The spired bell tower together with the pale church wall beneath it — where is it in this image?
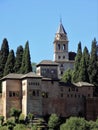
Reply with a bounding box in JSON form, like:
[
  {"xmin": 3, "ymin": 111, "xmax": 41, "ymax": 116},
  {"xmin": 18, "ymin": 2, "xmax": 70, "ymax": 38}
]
[{"xmin": 53, "ymin": 21, "xmax": 74, "ymax": 78}]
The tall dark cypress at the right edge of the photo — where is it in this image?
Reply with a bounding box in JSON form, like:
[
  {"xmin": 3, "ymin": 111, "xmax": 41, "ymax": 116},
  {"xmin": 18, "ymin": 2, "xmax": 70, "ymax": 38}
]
[{"xmin": 88, "ymin": 38, "xmax": 98, "ymax": 86}]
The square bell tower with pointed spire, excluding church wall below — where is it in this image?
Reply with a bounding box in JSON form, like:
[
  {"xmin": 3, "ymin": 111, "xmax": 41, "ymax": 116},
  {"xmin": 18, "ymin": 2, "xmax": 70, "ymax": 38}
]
[{"xmin": 53, "ymin": 21, "xmax": 69, "ymax": 62}]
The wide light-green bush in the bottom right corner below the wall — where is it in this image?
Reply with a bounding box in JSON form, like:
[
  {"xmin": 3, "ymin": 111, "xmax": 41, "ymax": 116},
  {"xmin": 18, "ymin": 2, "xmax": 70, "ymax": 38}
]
[{"xmin": 60, "ymin": 117, "xmax": 98, "ymax": 130}]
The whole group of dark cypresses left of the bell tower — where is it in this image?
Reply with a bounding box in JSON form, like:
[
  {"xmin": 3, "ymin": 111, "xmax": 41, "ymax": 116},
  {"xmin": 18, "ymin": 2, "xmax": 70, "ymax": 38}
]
[{"xmin": 0, "ymin": 38, "xmax": 32, "ymax": 92}]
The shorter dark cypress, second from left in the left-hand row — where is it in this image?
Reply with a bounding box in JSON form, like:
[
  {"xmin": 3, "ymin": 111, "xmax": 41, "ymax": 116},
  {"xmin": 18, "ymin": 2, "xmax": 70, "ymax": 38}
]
[{"xmin": 4, "ymin": 50, "xmax": 15, "ymax": 76}]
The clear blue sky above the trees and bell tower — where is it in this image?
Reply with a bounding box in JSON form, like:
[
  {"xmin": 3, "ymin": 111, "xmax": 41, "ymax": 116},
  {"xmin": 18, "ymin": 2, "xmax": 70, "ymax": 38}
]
[{"xmin": 0, "ymin": 0, "xmax": 98, "ymax": 63}]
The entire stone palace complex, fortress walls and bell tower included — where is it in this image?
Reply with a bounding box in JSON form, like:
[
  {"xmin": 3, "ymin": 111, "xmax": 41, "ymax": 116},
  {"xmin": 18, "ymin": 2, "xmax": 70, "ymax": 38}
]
[{"xmin": 0, "ymin": 23, "xmax": 98, "ymax": 120}]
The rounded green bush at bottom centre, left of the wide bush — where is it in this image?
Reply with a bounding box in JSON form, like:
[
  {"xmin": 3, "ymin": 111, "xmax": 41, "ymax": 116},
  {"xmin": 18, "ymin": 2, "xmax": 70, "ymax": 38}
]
[{"xmin": 48, "ymin": 114, "xmax": 59, "ymax": 130}]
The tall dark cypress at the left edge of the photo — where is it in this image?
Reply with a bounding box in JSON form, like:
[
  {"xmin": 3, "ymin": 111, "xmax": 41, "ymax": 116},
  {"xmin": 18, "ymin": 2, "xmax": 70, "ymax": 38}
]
[{"xmin": 0, "ymin": 38, "xmax": 9, "ymax": 78}]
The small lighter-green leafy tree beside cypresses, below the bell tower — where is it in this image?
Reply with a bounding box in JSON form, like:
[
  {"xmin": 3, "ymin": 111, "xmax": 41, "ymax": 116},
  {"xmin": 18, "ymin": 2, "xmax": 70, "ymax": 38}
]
[{"xmin": 61, "ymin": 69, "xmax": 72, "ymax": 83}]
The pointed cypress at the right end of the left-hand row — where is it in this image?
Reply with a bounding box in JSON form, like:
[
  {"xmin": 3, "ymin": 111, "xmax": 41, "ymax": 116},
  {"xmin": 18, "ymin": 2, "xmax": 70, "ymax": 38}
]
[{"xmin": 21, "ymin": 41, "xmax": 32, "ymax": 74}]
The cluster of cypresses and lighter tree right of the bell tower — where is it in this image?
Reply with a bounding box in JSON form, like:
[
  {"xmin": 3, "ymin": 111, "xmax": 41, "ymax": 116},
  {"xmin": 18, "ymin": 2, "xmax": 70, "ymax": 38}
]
[{"xmin": 62, "ymin": 38, "xmax": 98, "ymax": 86}]
